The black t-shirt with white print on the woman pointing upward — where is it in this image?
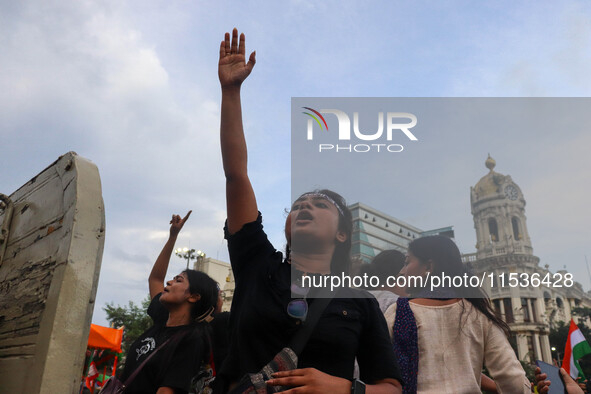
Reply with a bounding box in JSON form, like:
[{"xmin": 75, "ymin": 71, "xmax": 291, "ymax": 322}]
[{"xmin": 121, "ymin": 293, "xmax": 207, "ymax": 394}]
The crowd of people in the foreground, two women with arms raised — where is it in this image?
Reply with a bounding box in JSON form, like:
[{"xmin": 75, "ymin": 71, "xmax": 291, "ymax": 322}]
[{"xmin": 106, "ymin": 29, "xmax": 583, "ymax": 394}]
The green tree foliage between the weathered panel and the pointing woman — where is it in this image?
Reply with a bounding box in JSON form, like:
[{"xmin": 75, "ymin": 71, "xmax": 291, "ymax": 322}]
[{"xmin": 103, "ymin": 296, "xmax": 152, "ymax": 370}]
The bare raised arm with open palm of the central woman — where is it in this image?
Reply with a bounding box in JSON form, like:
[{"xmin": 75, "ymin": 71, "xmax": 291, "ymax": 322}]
[{"xmin": 218, "ymin": 29, "xmax": 258, "ymax": 234}]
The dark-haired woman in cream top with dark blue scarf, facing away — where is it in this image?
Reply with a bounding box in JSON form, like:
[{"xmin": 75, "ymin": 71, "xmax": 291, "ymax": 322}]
[{"xmin": 385, "ymin": 236, "xmax": 531, "ymax": 393}]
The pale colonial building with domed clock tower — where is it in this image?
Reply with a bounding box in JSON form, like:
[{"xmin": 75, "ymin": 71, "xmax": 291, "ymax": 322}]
[{"xmin": 463, "ymin": 156, "xmax": 591, "ymax": 362}]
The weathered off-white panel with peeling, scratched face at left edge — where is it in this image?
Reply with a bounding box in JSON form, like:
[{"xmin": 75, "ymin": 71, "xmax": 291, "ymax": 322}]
[{"xmin": 0, "ymin": 152, "xmax": 105, "ymax": 394}]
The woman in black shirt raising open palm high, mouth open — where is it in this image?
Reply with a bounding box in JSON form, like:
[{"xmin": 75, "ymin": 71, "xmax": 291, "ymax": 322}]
[{"xmin": 218, "ymin": 29, "xmax": 401, "ymax": 394}]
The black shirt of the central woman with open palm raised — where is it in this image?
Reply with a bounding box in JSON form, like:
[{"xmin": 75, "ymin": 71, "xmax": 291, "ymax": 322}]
[{"xmin": 221, "ymin": 214, "xmax": 401, "ymax": 383}]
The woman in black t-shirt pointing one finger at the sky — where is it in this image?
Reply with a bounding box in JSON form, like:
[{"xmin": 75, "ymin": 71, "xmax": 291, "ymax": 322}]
[{"xmin": 121, "ymin": 211, "xmax": 219, "ymax": 394}]
